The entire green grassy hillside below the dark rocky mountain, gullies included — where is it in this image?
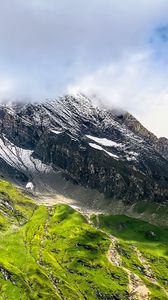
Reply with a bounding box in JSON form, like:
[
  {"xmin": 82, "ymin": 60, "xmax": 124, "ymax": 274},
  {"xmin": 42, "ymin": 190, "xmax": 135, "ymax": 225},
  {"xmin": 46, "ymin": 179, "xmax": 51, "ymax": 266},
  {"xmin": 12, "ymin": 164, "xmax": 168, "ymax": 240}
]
[{"xmin": 0, "ymin": 180, "xmax": 168, "ymax": 300}]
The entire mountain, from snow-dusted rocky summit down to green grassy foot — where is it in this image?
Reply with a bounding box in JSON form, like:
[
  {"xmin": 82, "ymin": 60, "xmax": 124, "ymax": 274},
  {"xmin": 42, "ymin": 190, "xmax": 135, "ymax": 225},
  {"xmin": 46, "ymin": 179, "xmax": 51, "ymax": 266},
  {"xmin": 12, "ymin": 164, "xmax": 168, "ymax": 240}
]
[{"xmin": 0, "ymin": 95, "xmax": 168, "ymax": 300}]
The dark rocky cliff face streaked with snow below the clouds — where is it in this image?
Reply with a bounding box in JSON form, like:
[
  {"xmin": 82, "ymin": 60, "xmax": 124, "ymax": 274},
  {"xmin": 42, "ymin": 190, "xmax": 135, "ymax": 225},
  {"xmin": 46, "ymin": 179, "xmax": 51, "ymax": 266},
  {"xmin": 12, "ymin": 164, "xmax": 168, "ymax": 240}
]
[{"xmin": 0, "ymin": 95, "xmax": 168, "ymax": 202}]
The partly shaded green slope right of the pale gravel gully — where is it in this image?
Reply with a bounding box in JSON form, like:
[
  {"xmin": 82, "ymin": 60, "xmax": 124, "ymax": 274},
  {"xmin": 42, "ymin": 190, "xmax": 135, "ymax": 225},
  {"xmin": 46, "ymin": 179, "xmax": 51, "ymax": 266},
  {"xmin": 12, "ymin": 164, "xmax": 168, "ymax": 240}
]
[{"xmin": 92, "ymin": 215, "xmax": 168, "ymax": 299}]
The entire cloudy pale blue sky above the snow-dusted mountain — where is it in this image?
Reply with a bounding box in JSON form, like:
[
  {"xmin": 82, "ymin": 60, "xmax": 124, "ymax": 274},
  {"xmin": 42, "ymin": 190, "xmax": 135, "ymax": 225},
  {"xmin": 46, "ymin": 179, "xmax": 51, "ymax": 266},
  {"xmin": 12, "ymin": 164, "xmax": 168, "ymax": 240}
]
[{"xmin": 0, "ymin": 0, "xmax": 168, "ymax": 137}]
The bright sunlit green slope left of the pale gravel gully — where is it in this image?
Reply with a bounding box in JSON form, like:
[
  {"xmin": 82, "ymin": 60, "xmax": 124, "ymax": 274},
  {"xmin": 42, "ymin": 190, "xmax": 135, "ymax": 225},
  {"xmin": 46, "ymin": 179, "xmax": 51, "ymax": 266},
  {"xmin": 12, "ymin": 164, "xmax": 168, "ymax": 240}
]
[{"xmin": 0, "ymin": 181, "xmax": 128, "ymax": 300}]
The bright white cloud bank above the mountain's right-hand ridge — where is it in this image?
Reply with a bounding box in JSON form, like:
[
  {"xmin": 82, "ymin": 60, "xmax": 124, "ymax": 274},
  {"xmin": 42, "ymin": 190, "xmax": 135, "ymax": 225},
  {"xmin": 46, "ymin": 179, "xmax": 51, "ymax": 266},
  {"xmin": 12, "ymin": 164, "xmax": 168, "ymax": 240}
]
[{"xmin": 68, "ymin": 49, "xmax": 168, "ymax": 137}]
